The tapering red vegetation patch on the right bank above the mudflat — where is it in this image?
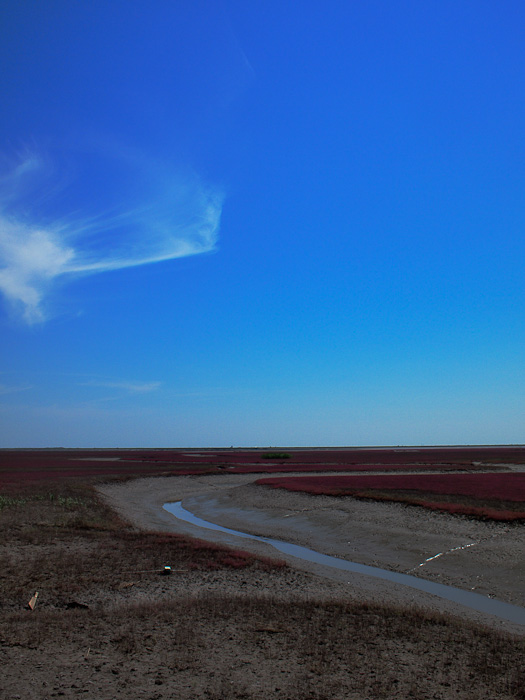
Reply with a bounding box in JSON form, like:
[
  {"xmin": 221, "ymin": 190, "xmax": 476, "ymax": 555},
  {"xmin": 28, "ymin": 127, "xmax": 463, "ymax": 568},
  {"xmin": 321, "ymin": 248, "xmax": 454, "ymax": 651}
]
[{"xmin": 256, "ymin": 472, "xmax": 525, "ymax": 521}]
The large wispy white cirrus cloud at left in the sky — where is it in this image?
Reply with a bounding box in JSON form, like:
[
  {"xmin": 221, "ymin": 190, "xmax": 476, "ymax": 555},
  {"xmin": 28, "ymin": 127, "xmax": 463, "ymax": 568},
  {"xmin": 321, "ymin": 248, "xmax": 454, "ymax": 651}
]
[{"xmin": 0, "ymin": 154, "xmax": 223, "ymax": 324}]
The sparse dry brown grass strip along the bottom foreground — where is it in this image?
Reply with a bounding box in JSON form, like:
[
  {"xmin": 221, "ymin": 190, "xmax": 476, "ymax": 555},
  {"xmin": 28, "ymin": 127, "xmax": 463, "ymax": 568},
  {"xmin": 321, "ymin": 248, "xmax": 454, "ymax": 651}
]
[{"xmin": 2, "ymin": 594, "xmax": 525, "ymax": 700}]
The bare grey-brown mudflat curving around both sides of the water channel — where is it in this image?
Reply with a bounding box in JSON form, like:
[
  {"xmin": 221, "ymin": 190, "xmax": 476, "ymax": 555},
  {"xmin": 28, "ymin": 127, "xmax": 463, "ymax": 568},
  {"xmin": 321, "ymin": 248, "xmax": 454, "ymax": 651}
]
[{"xmin": 99, "ymin": 474, "xmax": 525, "ymax": 634}]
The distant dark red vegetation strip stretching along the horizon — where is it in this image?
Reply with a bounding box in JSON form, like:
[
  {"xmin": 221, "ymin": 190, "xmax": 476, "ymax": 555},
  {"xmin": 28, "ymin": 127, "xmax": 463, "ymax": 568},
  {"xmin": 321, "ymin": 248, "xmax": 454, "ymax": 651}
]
[{"xmin": 0, "ymin": 446, "xmax": 525, "ymax": 490}]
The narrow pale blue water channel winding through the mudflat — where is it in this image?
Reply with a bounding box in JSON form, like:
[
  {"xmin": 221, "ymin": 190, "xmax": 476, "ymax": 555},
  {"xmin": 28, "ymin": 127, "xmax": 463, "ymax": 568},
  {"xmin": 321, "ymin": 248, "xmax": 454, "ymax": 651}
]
[{"xmin": 164, "ymin": 501, "xmax": 525, "ymax": 625}]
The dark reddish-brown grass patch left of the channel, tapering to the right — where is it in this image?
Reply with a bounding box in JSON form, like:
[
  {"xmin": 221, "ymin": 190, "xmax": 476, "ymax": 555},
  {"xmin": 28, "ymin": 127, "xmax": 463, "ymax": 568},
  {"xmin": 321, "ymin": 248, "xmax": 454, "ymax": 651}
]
[{"xmin": 0, "ymin": 481, "xmax": 285, "ymax": 610}]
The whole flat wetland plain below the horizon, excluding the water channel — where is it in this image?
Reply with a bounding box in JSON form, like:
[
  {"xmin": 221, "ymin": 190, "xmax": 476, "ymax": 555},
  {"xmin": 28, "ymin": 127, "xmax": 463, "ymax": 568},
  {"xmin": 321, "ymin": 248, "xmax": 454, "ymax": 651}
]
[{"xmin": 0, "ymin": 446, "xmax": 525, "ymax": 700}]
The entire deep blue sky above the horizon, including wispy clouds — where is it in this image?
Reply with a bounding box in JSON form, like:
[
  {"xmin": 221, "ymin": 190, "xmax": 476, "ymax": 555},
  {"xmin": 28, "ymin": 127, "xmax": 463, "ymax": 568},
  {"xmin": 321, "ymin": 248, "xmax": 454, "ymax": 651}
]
[{"xmin": 0, "ymin": 0, "xmax": 525, "ymax": 447}]
